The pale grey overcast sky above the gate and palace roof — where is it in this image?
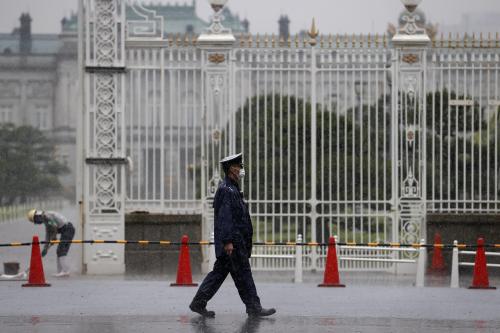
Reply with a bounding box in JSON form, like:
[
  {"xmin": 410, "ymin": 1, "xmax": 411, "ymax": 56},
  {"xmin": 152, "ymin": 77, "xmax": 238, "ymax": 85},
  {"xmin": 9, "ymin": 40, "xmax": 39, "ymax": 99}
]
[{"xmin": 0, "ymin": 0, "xmax": 500, "ymax": 34}]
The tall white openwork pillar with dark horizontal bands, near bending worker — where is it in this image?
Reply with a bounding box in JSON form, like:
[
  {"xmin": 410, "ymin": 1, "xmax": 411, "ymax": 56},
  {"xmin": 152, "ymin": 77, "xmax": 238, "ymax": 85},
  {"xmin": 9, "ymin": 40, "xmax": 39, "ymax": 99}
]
[{"xmin": 79, "ymin": 0, "xmax": 126, "ymax": 274}]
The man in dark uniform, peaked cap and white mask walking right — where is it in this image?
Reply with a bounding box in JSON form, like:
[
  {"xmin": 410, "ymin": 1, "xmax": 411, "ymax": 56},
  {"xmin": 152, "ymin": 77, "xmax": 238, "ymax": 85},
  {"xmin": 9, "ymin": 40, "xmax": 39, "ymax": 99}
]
[{"xmin": 189, "ymin": 153, "xmax": 276, "ymax": 317}]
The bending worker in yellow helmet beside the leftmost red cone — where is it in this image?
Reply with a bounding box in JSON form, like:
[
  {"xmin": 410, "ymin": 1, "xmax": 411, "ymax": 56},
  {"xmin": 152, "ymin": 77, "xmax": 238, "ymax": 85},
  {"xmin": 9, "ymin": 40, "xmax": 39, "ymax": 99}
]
[{"xmin": 28, "ymin": 209, "xmax": 75, "ymax": 277}]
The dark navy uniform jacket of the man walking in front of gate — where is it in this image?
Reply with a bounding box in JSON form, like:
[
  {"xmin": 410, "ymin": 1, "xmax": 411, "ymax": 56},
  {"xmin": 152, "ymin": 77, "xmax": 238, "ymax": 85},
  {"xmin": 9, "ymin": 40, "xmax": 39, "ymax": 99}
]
[{"xmin": 213, "ymin": 177, "xmax": 253, "ymax": 258}]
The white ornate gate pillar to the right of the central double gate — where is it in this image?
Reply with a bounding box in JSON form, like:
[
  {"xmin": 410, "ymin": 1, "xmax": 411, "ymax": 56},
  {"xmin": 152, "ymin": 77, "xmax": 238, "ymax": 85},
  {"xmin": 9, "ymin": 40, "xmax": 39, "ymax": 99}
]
[{"xmin": 392, "ymin": 0, "xmax": 430, "ymax": 249}]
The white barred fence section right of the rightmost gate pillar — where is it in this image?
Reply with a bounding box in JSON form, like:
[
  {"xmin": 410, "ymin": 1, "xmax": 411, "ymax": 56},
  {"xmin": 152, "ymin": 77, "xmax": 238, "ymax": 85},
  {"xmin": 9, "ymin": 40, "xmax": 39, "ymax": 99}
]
[{"xmin": 426, "ymin": 44, "xmax": 500, "ymax": 213}]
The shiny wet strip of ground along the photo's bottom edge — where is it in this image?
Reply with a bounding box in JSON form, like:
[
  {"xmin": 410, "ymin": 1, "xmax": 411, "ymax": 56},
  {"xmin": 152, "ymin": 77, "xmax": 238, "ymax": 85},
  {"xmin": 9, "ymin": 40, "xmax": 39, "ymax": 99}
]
[{"xmin": 0, "ymin": 315, "xmax": 500, "ymax": 333}]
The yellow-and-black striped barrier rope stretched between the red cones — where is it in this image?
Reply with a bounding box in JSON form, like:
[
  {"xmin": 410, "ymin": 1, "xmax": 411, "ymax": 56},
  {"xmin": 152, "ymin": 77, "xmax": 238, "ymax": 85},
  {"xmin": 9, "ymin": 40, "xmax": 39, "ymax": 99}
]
[{"xmin": 0, "ymin": 239, "xmax": 500, "ymax": 249}]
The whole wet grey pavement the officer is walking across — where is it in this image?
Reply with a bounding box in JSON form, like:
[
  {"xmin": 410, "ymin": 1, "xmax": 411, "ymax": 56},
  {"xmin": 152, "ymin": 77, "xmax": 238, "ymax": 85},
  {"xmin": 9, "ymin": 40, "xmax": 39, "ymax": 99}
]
[{"xmin": 0, "ymin": 277, "xmax": 500, "ymax": 333}]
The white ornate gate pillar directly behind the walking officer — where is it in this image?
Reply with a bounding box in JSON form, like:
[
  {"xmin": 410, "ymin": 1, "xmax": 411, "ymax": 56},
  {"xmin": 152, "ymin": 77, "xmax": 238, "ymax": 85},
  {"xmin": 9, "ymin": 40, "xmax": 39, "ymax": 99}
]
[{"xmin": 197, "ymin": 5, "xmax": 236, "ymax": 271}]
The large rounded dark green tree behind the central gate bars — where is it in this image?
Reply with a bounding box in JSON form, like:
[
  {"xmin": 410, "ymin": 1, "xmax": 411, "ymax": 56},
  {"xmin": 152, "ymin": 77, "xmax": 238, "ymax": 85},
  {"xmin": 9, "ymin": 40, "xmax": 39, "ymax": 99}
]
[{"xmin": 236, "ymin": 95, "xmax": 391, "ymax": 204}]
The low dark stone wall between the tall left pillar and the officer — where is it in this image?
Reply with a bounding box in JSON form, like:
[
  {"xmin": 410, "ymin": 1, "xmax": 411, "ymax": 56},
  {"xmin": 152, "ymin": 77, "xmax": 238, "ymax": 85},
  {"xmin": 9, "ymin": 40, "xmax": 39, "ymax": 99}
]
[{"xmin": 125, "ymin": 213, "xmax": 202, "ymax": 277}]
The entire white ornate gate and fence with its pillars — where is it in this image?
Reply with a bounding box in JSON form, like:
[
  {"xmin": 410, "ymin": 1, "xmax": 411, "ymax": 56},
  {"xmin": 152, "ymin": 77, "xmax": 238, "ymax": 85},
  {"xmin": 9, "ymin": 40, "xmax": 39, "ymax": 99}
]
[{"xmin": 82, "ymin": 0, "xmax": 500, "ymax": 272}]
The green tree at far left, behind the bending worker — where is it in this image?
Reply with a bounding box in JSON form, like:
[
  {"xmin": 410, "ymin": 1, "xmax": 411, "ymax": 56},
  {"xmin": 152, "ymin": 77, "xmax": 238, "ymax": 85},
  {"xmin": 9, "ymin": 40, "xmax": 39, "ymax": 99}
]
[{"xmin": 0, "ymin": 124, "xmax": 68, "ymax": 205}]
